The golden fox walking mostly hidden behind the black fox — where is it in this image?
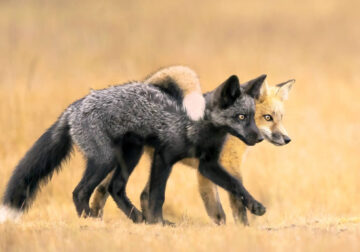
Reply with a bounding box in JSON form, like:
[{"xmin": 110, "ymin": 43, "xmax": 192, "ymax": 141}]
[{"xmin": 91, "ymin": 66, "xmax": 295, "ymax": 225}]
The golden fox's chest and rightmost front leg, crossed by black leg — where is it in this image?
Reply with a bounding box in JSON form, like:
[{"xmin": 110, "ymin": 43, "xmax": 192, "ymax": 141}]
[{"xmin": 220, "ymin": 136, "xmax": 249, "ymax": 226}]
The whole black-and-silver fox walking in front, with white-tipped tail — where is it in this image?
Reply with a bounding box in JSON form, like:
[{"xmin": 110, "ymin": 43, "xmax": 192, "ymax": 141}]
[{"xmin": 0, "ymin": 69, "xmax": 266, "ymax": 224}]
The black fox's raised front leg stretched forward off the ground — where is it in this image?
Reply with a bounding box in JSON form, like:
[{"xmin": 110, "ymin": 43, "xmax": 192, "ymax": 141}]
[{"xmin": 199, "ymin": 154, "xmax": 266, "ymax": 215}]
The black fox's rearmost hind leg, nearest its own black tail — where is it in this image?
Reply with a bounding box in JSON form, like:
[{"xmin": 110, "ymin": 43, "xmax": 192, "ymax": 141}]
[{"xmin": 73, "ymin": 158, "xmax": 115, "ymax": 217}]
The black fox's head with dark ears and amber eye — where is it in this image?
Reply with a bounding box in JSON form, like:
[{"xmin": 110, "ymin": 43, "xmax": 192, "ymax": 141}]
[{"xmin": 205, "ymin": 75, "xmax": 266, "ymax": 145}]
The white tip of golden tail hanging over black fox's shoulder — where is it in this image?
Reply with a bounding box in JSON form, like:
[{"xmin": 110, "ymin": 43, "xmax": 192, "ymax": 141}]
[{"xmin": 183, "ymin": 92, "xmax": 205, "ymax": 121}]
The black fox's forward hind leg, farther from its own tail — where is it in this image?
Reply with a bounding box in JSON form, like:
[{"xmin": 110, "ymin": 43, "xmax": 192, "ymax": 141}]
[{"xmin": 108, "ymin": 135, "xmax": 144, "ymax": 223}]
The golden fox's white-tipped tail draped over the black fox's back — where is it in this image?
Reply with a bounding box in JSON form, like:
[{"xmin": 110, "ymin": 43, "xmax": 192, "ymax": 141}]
[{"xmin": 144, "ymin": 66, "xmax": 205, "ymax": 121}]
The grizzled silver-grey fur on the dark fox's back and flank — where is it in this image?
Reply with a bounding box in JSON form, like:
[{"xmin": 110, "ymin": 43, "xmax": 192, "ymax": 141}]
[{"xmin": 67, "ymin": 83, "xmax": 188, "ymax": 158}]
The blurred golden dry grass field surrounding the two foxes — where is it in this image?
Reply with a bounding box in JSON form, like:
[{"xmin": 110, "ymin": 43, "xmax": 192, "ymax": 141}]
[{"xmin": 0, "ymin": 0, "xmax": 360, "ymax": 251}]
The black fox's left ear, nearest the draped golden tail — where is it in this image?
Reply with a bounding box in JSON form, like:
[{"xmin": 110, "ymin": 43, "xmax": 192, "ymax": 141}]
[{"xmin": 215, "ymin": 75, "xmax": 241, "ymax": 108}]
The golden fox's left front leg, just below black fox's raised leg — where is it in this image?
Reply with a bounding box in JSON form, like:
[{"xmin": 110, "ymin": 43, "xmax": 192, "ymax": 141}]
[{"xmin": 197, "ymin": 172, "xmax": 226, "ymax": 225}]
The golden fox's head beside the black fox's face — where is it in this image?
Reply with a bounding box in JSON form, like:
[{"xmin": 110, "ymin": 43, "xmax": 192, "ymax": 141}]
[{"xmin": 255, "ymin": 80, "xmax": 295, "ymax": 146}]
